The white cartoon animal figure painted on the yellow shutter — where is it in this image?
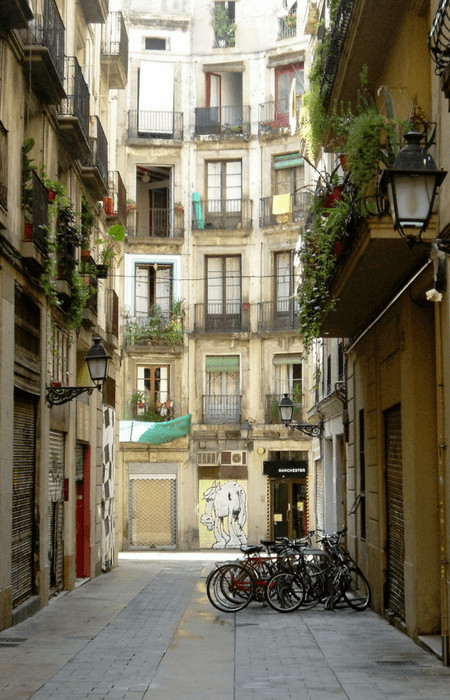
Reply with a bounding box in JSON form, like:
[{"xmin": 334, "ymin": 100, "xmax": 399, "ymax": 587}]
[{"xmin": 200, "ymin": 481, "xmax": 247, "ymax": 549}]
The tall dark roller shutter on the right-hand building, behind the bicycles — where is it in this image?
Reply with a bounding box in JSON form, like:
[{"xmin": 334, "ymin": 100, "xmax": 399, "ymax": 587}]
[{"xmin": 384, "ymin": 406, "xmax": 405, "ymax": 620}]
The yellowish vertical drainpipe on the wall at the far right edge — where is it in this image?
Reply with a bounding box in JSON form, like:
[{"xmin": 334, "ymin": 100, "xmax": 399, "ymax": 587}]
[{"xmin": 434, "ymin": 302, "xmax": 450, "ymax": 666}]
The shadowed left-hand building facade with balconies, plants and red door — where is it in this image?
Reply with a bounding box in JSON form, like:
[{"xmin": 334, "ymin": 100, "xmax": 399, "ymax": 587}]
[{"xmin": 0, "ymin": 0, "xmax": 128, "ymax": 628}]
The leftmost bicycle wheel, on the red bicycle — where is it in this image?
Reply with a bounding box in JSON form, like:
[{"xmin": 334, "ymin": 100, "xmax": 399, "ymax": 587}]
[{"xmin": 206, "ymin": 563, "xmax": 255, "ymax": 612}]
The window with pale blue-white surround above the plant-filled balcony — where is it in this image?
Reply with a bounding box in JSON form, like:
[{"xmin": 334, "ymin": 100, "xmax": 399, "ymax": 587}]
[{"xmin": 135, "ymin": 263, "xmax": 173, "ymax": 323}]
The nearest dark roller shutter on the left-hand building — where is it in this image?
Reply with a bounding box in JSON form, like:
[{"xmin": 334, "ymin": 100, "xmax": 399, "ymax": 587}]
[{"xmin": 11, "ymin": 392, "xmax": 36, "ymax": 606}]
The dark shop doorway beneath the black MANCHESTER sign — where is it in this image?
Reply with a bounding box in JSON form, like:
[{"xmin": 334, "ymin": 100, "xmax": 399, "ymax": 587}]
[{"xmin": 270, "ymin": 479, "xmax": 308, "ymax": 539}]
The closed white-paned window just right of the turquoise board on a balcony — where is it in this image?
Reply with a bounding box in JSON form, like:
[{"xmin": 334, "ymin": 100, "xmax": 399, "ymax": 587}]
[{"xmin": 206, "ymin": 160, "xmax": 242, "ymax": 217}]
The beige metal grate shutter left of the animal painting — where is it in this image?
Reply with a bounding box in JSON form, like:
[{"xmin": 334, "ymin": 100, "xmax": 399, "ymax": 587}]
[{"xmin": 129, "ymin": 475, "xmax": 176, "ymax": 549}]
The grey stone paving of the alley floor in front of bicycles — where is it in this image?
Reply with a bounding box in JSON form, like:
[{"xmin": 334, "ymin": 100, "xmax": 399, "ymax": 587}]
[{"xmin": 0, "ymin": 554, "xmax": 450, "ymax": 700}]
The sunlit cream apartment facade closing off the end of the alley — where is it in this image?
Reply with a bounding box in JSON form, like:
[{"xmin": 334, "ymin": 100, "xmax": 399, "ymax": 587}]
[{"xmin": 119, "ymin": 1, "xmax": 320, "ymax": 549}]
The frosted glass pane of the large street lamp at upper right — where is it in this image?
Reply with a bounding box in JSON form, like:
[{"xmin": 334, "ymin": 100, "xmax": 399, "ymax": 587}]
[{"xmin": 388, "ymin": 173, "xmax": 435, "ymax": 228}]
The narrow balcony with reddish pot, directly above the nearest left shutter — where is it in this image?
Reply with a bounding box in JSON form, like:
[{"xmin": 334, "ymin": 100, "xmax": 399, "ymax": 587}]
[{"xmin": 20, "ymin": 171, "xmax": 48, "ymax": 271}]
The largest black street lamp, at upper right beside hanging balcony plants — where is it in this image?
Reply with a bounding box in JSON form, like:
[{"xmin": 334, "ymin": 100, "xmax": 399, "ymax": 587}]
[{"xmin": 380, "ymin": 131, "xmax": 447, "ymax": 245}]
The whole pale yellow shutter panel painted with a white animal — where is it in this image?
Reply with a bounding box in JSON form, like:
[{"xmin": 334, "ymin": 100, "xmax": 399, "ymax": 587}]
[{"xmin": 199, "ymin": 479, "xmax": 247, "ymax": 549}]
